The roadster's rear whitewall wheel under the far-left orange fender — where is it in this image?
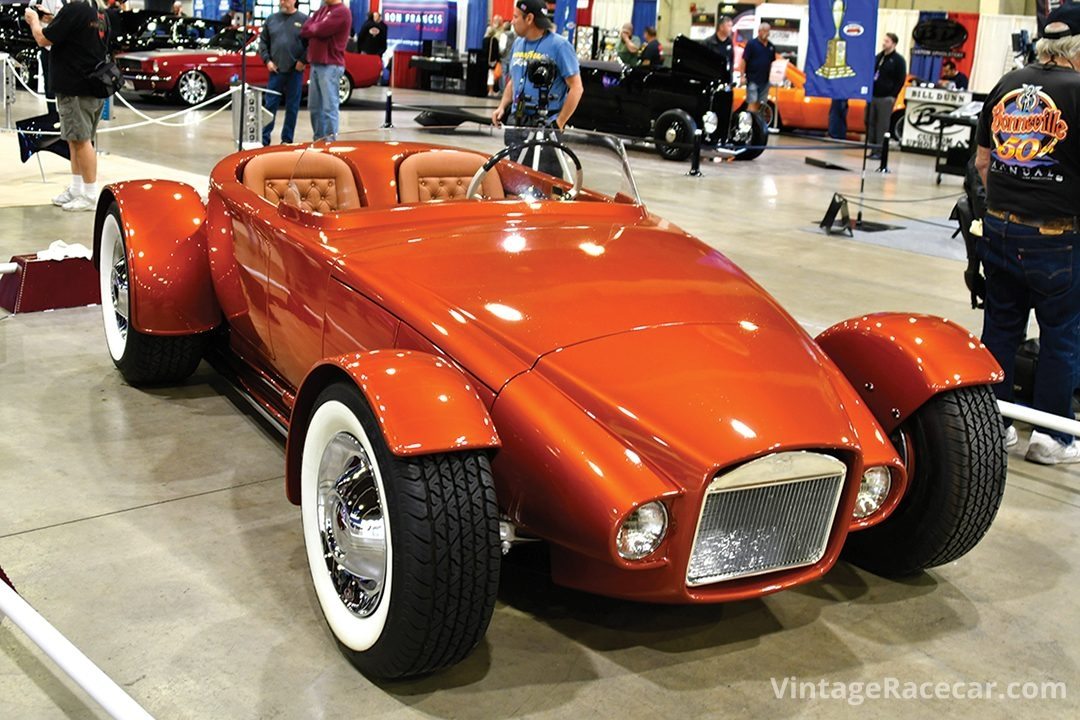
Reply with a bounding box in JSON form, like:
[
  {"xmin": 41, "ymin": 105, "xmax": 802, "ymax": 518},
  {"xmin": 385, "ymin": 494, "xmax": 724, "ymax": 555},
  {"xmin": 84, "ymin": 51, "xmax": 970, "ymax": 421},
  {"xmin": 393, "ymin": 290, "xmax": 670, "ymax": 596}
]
[{"xmin": 98, "ymin": 203, "xmax": 206, "ymax": 385}]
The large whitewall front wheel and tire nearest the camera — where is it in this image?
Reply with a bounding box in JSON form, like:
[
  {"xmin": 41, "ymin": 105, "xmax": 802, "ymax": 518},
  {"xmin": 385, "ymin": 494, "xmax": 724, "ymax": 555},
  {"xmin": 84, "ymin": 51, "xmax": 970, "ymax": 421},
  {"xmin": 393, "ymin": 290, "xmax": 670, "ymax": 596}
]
[{"xmin": 300, "ymin": 383, "xmax": 501, "ymax": 678}]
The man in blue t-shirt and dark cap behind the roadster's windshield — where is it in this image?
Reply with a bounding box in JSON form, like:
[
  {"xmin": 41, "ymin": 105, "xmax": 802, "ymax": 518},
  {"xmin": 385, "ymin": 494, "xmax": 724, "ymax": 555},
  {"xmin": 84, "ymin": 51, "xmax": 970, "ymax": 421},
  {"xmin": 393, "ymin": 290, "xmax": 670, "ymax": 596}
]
[{"xmin": 491, "ymin": 0, "xmax": 584, "ymax": 130}]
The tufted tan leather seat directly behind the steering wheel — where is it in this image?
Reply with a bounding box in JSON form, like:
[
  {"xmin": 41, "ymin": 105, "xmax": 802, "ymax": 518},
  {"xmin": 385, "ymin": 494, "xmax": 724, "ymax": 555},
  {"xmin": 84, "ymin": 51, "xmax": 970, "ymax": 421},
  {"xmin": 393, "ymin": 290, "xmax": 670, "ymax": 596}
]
[{"xmin": 397, "ymin": 150, "xmax": 505, "ymax": 203}]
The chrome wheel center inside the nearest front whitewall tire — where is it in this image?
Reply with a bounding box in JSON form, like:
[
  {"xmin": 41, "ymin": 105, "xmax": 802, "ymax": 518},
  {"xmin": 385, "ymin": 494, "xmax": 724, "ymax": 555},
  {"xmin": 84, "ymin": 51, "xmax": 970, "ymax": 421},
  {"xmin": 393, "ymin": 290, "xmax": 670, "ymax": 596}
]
[{"xmin": 316, "ymin": 432, "xmax": 387, "ymax": 617}]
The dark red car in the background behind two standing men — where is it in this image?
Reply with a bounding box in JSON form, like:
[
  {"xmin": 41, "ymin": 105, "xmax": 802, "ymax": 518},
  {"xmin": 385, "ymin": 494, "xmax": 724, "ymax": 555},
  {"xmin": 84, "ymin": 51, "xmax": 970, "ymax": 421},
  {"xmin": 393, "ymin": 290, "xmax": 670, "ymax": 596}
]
[{"xmin": 117, "ymin": 27, "xmax": 382, "ymax": 106}]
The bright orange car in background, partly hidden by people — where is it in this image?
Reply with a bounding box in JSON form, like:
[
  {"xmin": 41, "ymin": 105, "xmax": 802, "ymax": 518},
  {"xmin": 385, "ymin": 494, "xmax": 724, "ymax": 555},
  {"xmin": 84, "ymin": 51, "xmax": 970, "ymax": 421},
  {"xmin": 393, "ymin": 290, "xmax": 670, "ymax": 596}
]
[{"xmin": 732, "ymin": 64, "xmax": 916, "ymax": 138}]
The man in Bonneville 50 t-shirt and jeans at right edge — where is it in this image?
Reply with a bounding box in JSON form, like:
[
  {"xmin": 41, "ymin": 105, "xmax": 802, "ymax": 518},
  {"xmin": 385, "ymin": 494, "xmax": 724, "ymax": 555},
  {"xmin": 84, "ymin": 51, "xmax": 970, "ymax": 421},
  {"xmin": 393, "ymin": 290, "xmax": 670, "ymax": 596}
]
[{"xmin": 975, "ymin": 5, "xmax": 1080, "ymax": 464}]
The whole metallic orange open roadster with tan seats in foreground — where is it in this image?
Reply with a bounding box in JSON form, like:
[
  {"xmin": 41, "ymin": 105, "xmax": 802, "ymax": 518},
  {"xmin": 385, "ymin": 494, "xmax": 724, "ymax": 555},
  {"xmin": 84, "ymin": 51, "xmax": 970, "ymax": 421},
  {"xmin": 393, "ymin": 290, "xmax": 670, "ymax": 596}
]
[{"xmin": 94, "ymin": 132, "xmax": 1005, "ymax": 678}]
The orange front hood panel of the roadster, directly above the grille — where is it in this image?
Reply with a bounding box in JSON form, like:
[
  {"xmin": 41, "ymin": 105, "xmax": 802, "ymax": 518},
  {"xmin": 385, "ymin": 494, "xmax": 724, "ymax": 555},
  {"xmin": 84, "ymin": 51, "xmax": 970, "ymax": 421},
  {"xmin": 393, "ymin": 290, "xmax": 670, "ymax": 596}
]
[{"xmin": 527, "ymin": 322, "xmax": 859, "ymax": 487}]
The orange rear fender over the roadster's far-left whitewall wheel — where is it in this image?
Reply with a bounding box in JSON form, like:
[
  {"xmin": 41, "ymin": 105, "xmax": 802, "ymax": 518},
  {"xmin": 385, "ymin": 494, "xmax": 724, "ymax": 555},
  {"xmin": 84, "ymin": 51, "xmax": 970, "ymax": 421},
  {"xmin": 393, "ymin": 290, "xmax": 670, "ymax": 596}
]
[{"xmin": 94, "ymin": 180, "xmax": 221, "ymax": 335}]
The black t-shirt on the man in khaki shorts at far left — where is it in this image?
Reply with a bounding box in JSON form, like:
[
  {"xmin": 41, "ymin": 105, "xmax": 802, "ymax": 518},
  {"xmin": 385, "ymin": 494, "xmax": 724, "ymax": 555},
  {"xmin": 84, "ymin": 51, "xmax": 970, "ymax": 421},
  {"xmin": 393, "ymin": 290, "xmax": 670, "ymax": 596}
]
[{"xmin": 43, "ymin": 2, "xmax": 107, "ymax": 95}]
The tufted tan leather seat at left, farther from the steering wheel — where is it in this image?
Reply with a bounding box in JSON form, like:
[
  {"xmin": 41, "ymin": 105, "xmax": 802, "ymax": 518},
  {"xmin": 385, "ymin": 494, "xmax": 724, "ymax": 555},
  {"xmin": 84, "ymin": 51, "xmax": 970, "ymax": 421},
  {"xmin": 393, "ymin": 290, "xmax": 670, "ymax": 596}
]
[{"xmin": 244, "ymin": 150, "xmax": 363, "ymax": 213}]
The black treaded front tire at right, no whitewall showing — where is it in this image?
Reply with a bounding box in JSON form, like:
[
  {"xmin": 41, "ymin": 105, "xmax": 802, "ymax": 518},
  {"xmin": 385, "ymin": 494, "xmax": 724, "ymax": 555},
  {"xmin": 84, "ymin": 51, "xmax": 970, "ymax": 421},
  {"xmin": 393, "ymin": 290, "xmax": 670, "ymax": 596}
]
[{"xmin": 843, "ymin": 385, "xmax": 1008, "ymax": 576}]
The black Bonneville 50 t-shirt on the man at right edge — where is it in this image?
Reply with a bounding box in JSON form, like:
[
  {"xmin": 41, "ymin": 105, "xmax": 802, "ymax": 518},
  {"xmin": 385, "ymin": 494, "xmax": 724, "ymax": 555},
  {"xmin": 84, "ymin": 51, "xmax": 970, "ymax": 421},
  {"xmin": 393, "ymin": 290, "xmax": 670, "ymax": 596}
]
[{"xmin": 976, "ymin": 64, "xmax": 1080, "ymax": 219}]
